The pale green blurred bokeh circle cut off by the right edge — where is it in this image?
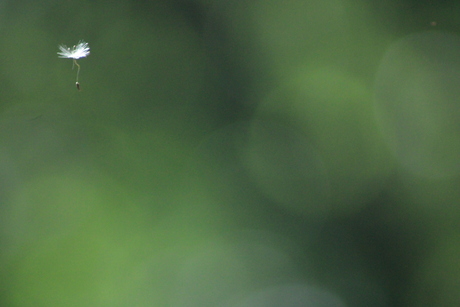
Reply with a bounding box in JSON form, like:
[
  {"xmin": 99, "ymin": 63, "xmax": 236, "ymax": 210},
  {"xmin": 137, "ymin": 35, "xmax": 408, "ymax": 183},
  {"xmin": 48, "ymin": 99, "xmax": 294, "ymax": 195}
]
[{"xmin": 375, "ymin": 31, "xmax": 460, "ymax": 178}]
